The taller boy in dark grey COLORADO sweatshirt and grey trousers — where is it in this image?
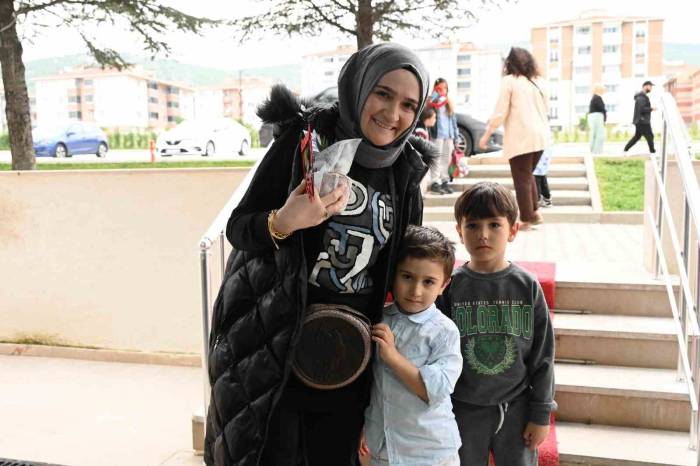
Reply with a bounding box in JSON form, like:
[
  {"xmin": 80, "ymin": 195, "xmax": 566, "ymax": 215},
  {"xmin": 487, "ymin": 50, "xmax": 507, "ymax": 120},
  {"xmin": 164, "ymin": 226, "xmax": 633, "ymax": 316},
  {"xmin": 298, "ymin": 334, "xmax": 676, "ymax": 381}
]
[{"xmin": 438, "ymin": 182, "xmax": 556, "ymax": 466}]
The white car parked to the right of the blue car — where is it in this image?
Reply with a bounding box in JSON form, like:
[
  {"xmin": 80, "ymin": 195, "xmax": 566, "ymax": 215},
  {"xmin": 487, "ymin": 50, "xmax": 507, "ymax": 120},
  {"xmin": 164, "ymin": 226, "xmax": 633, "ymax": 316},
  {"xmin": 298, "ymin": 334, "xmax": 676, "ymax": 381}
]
[{"xmin": 156, "ymin": 118, "xmax": 250, "ymax": 157}]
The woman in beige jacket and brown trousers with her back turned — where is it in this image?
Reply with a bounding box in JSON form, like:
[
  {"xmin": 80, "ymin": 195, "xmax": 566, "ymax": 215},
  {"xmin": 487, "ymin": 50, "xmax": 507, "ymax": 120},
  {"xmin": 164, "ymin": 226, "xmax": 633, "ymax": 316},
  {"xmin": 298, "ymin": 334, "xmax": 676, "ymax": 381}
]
[{"xmin": 479, "ymin": 47, "xmax": 548, "ymax": 230}]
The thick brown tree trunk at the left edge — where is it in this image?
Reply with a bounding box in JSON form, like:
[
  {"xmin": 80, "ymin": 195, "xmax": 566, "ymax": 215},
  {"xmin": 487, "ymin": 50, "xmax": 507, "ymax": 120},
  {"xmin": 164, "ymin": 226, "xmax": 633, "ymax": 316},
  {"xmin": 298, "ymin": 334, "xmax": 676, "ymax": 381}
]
[{"xmin": 0, "ymin": 0, "xmax": 36, "ymax": 170}]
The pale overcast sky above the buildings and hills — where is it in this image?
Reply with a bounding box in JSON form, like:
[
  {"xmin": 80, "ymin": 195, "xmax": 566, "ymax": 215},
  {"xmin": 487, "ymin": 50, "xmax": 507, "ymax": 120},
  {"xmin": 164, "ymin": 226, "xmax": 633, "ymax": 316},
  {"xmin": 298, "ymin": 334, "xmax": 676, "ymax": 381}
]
[{"xmin": 19, "ymin": 0, "xmax": 700, "ymax": 68}]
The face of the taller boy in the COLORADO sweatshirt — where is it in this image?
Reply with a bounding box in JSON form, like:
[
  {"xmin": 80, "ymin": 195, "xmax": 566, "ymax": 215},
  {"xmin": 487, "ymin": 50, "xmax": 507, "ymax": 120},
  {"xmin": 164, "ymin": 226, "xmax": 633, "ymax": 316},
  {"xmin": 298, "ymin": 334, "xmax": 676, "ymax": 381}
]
[{"xmin": 457, "ymin": 216, "xmax": 518, "ymax": 268}]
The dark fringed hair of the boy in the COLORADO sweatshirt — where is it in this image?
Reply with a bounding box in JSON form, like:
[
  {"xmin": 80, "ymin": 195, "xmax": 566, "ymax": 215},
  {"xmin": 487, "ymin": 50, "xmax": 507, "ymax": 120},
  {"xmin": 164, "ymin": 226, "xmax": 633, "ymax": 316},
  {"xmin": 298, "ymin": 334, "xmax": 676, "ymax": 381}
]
[{"xmin": 455, "ymin": 181, "xmax": 518, "ymax": 226}]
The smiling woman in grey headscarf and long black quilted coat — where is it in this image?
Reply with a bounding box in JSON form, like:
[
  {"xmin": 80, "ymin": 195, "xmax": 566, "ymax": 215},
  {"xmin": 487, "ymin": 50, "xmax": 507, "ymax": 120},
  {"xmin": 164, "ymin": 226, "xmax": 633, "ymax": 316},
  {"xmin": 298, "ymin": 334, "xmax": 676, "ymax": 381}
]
[{"xmin": 204, "ymin": 44, "xmax": 437, "ymax": 466}]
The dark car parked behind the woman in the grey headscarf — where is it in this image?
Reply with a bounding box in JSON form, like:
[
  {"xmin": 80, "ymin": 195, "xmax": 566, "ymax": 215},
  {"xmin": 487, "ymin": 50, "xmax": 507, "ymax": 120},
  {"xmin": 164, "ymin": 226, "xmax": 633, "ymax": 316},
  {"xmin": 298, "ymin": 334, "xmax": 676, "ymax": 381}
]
[{"xmin": 259, "ymin": 86, "xmax": 503, "ymax": 156}]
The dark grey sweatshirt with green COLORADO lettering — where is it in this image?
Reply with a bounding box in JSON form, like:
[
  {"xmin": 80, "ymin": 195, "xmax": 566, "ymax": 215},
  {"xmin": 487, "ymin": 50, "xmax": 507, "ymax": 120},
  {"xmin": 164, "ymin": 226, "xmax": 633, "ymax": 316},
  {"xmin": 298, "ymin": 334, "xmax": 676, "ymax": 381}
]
[{"xmin": 438, "ymin": 264, "xmax": 556, "ymax": 425}]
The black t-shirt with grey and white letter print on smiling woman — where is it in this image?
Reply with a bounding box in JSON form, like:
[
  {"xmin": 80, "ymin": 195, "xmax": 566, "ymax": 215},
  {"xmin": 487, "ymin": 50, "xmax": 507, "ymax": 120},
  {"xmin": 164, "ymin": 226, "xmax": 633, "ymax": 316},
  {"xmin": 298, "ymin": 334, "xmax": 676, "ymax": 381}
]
[{"xmin": 305, "ymin": 164, "xmax": 395, "ymax": 312}]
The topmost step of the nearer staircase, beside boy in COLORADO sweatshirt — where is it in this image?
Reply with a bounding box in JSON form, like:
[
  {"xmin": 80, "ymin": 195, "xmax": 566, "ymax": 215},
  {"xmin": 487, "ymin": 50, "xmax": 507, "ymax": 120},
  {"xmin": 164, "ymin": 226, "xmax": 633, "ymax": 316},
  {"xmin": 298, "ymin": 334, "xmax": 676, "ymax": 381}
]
[{"xmin": 556, "ymin": 277, "xmax": 671, "ymax": 317}]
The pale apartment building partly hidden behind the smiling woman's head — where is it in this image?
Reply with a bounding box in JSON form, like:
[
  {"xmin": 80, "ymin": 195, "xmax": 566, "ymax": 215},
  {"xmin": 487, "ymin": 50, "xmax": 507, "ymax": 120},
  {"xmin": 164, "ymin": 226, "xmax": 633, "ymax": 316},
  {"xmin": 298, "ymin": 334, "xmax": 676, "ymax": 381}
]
[{"xmin": 301, "ymin": 42, "xmax": 503, "ymax": 119}]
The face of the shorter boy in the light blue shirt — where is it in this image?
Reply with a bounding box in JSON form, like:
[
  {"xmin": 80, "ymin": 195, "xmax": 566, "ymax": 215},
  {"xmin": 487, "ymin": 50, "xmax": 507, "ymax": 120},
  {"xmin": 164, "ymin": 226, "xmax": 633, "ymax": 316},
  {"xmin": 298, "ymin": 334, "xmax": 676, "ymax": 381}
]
[{"xmin": 393, "ymin": 257, "xmax": 448, "ymax": 314}]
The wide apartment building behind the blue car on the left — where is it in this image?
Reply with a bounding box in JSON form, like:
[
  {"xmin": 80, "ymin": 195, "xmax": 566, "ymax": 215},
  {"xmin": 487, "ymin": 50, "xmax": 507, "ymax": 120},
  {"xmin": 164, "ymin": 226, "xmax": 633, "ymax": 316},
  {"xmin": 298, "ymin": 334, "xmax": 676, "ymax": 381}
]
[{"xmin": 35, "ymin": 68, "xmax": 194, "ymax": 130}]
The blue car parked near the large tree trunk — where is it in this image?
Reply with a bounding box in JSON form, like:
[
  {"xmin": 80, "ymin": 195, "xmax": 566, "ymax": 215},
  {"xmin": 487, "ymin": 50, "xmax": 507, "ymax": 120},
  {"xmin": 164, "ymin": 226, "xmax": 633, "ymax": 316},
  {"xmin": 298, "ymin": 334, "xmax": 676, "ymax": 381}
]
[{"xmin": 32, "ymin": 121, "xmax": 109, "ymax": 158}]
